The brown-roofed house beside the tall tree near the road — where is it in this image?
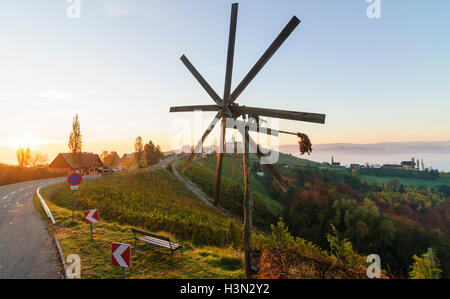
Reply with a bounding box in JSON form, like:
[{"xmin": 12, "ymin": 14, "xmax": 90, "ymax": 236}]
[{"xmin": 49, "ymin": 153, "xmax": 103, "ymax": 174}]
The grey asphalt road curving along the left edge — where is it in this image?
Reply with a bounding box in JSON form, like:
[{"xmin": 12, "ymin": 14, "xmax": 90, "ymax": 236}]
[{"xmin": 0, "ymin": 179, "xmax": 65, "ymax": 279}]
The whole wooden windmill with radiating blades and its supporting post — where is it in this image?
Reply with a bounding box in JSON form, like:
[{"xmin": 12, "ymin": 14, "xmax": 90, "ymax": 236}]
[{"xmin": 170, "ymin": 3, "xmax": 325, "ymax": 277}]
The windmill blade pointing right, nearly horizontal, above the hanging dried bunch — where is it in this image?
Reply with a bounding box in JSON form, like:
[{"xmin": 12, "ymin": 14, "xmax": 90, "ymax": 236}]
[{"xmin": 232, "ymin": 106, "xmax": 326, "ymax": 124}]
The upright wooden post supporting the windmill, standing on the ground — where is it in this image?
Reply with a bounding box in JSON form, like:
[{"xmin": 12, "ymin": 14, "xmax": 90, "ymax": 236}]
[{"xmin": 243, "ymin": 126, "xmax": 253, "ymax": 279}]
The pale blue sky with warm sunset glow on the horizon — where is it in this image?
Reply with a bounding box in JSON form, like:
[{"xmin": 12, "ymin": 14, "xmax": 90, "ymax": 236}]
[{"xmin": 0, "ymin": 0, "xmax": 450, "ymax": 163}]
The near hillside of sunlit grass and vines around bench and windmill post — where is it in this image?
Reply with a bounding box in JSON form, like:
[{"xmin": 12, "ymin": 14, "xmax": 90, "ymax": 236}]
[{"xmin": 39, "ymin": 165, "xmax": 372, "ymax": 279}]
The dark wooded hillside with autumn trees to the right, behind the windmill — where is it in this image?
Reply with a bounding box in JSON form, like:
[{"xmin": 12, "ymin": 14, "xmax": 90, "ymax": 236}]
[{"xmin": 177, "ymin": 154, "xmax": 450, "ymax": 277}]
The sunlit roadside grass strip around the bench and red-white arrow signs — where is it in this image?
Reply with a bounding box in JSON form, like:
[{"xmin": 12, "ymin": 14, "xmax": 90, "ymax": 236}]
[{"xmin": 35, "ymin": 185, "xmax": 243, "ymax": 279}]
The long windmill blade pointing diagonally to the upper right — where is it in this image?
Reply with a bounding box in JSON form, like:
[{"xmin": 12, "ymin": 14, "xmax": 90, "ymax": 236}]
[{"xmin": 229, "ymin": 16, "xmax": 300, "ymax": 104}]
